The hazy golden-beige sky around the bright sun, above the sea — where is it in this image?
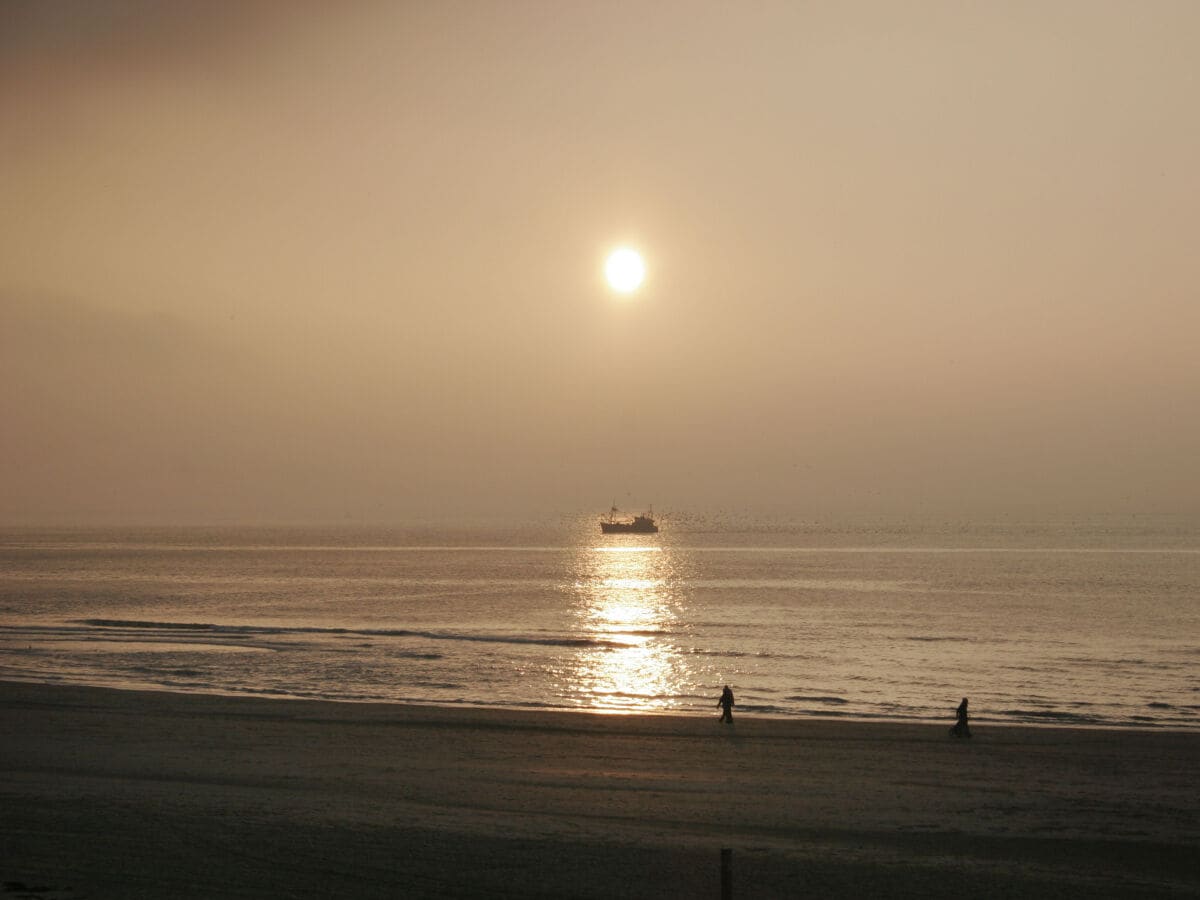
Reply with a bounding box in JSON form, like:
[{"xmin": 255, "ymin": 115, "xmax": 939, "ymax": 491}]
[{"xmin": 0, "ymin": 0, "xmax": 1200, "ymax": 523}]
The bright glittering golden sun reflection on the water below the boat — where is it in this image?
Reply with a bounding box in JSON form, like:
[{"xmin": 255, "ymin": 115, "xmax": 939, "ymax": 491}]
[{"xmin": 564, "ymin": 544, "xmax": 690, "ymax": 712}]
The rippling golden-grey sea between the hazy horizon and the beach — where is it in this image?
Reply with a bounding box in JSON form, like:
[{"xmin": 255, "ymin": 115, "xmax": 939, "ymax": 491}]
[{"xmin": 0, "ymin": 515, "xmax": 1200, "ymax": 730}]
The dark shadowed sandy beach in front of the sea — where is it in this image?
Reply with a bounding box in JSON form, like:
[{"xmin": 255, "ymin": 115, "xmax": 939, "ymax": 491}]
[{"xmin": 0, "ymin": 683, "xmax": 1200, "ymax": 898}]
